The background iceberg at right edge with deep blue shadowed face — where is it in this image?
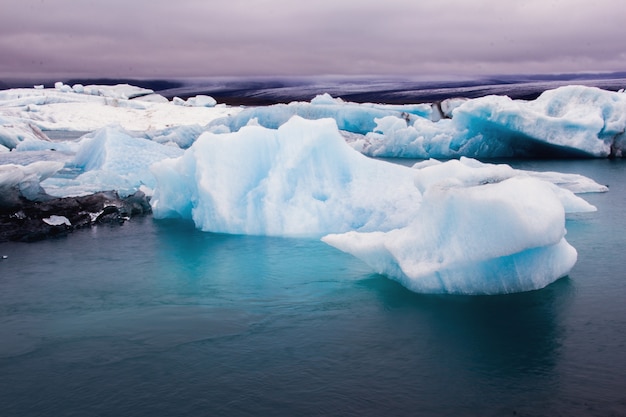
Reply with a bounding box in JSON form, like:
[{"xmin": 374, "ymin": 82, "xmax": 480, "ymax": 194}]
[{"xmin": 352, "ymin": 86, "xmax": 626, "ymax": 158}]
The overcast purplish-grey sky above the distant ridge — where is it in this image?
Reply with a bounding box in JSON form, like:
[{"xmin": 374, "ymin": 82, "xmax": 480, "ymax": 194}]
[{"xmin": 0, "ymin": 0, "xmax": 626, "ymax": 78}]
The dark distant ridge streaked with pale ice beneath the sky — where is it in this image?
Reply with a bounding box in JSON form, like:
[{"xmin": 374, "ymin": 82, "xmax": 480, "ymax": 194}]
[{"xmin": 0, "ymin": 71, "xmax": 626, "ymax": 106}]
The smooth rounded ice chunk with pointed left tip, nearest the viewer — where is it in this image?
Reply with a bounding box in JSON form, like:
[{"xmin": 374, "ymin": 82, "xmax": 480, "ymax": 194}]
[{"xmin": 322, "ymin": 178, "xmax": 577, "ymax": 294}]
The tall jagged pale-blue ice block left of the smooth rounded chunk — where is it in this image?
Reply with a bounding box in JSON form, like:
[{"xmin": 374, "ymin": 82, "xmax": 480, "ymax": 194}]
[{"xmin": 151, "ymin": 117, "xmax": 421, "ymax": 236}]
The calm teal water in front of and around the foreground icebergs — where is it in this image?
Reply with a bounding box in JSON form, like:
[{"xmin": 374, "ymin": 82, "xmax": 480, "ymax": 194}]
[{"xmin": 0, "ymin": 161, "xmax": 626, "ymax": 416}]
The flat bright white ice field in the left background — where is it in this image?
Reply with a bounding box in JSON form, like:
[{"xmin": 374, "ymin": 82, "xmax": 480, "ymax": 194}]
[{"xmin": 0, "ymin": 83, "xmax": 241, "ymax": 139}]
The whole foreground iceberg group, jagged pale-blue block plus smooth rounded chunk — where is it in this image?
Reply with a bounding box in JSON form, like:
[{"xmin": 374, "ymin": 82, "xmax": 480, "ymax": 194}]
[{"xmin": 152, "ymin": 116, "xmax": 606, "ymax": 294}]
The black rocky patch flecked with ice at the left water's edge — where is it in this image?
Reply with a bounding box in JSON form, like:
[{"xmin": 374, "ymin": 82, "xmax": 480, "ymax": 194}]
[{"xmin": 0, "ymin": 191, "xmax": 152, "ymax": 242}]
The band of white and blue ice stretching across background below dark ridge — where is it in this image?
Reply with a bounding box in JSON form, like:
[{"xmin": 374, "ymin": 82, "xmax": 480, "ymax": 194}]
[{"xmin": 0, "ymin": 83, "xmax": 626, "ymax": 158}]
